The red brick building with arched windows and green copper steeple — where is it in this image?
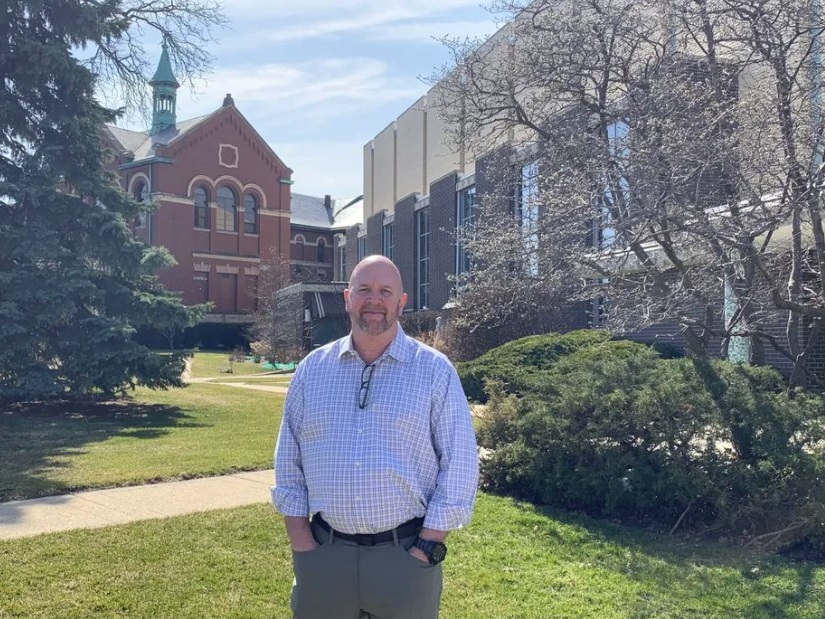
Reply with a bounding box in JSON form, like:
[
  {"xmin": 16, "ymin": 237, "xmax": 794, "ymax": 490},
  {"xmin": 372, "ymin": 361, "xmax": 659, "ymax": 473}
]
[{"xmin": 104, "ymin": 44, "xmax": 308, "ymax": 344}]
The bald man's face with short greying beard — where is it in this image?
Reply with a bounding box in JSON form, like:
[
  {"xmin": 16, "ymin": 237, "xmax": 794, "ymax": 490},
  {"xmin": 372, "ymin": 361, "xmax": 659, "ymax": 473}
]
[{"xmin": 344, "ymin": 262, "xmax": 407, "ymax": 336}]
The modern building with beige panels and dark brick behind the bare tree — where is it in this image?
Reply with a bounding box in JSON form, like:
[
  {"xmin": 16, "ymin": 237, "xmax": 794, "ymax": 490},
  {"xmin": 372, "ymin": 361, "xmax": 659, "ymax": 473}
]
[{"xmin": 346, "ymin": 4, "xmax": 825, "ymax": 375}]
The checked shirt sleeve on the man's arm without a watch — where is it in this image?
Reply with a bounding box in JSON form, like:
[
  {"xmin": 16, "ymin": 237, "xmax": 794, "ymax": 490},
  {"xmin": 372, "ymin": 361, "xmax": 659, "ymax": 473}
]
[{"xmin": 271, "ymin": 368, "xmax": 309, "ymax": 517}]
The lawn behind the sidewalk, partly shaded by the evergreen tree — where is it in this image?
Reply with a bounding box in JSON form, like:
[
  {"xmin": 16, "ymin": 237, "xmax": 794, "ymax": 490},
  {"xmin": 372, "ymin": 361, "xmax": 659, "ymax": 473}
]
[{"xmin": 0, "ymin": 383, "xmax": 284, "ymax": 501}]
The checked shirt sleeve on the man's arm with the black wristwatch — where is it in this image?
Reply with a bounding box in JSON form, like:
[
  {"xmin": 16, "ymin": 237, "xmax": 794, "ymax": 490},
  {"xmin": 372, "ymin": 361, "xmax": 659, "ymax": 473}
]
[{"xmin": 424, "ymin": 363, "xmax": 478, "ymax": 531}]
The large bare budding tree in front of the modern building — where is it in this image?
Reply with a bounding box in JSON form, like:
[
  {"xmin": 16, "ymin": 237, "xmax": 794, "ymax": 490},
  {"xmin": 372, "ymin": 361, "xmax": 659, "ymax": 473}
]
[{"xmin": 436, "ymin": 0, "xmax": 825, "ymax": 386}]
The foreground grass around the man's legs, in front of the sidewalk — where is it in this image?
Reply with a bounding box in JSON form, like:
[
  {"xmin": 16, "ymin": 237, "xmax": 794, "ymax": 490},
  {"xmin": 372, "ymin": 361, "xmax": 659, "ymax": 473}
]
[{"xmin": 0, "ymin": 495, "xmax": 825, "ymax": 619}]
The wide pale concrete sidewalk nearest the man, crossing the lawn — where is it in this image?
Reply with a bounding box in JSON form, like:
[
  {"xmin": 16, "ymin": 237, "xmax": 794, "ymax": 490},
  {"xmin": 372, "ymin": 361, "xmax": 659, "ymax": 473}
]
[{"xmin": 0, "ymin": 469, "xmax": 274, "ymax": 540}]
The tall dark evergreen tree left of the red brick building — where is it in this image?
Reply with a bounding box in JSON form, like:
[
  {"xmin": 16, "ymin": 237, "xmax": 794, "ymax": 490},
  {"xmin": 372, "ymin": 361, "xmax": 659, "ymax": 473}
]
[{"xmin": 0, "ymin": 0, "xmax": 221, "ymax": 400}]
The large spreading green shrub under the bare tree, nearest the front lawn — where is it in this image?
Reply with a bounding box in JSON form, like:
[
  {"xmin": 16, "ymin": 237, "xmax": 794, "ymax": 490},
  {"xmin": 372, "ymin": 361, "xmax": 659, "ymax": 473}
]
[{"xmin": 478, "ymin": 341, "xmax": 825, "ymax": 549}]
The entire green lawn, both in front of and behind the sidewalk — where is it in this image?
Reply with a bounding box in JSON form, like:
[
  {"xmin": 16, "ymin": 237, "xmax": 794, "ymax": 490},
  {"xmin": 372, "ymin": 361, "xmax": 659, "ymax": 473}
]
[{"xmin": 0, "ymin": 353, "xmax": 825, "ymax": 619}]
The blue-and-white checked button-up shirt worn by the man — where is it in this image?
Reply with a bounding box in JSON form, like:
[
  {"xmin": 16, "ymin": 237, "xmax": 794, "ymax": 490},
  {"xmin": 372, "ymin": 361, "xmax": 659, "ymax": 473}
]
[{"xmin": 272, "ymin": 326, "xmax": 478, "ymax": 533}]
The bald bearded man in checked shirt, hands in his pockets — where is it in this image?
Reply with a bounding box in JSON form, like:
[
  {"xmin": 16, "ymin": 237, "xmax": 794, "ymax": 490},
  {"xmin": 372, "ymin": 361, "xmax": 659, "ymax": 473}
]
[{"xmin": 272, "ymin": 256, "xmax": 478, "ymax": 619}]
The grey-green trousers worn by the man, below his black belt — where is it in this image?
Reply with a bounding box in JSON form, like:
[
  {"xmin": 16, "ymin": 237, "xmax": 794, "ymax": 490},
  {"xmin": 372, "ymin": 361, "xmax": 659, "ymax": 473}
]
[{"xmin": 292, "ymin": 525, "xmax": 442, "ymax": 619}]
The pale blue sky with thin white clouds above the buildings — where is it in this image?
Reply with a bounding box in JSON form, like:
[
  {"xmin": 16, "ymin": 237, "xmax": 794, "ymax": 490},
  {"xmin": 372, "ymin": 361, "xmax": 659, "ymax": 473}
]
[{"xmin": 110, "ymin": 0, "xmax": 500, "ymax": 198}]
